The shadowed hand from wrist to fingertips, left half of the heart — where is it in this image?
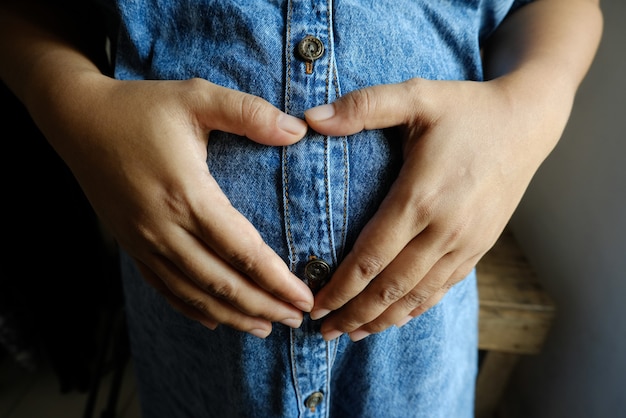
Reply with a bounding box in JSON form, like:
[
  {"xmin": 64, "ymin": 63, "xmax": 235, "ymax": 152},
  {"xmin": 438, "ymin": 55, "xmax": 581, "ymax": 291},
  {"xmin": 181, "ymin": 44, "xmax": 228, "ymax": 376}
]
[{"xmin": 40, "ymin": 74, "xmax": 313, "ymax": 338}]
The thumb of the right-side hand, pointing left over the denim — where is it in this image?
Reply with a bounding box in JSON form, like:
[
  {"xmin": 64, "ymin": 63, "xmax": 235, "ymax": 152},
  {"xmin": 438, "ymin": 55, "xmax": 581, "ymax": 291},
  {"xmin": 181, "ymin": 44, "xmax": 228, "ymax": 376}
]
[{"xmin": 304, "ymin": 82, "xmax": 411, "ymax": 136}]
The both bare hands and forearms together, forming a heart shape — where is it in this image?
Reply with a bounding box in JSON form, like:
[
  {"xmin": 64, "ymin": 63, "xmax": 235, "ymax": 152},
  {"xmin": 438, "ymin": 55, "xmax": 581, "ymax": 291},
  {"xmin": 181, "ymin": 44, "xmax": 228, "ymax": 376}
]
[{"xmin": 0, "ymin": 0, "xmax": 601, "ymax": 340}]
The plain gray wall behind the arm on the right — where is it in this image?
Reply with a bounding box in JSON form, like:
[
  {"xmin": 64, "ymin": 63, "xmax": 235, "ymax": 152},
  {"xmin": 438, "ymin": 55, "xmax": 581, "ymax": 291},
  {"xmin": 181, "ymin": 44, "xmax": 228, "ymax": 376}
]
[{"xmin": 509, "ymin": 0, "xmax": 626, "ymax": 418}]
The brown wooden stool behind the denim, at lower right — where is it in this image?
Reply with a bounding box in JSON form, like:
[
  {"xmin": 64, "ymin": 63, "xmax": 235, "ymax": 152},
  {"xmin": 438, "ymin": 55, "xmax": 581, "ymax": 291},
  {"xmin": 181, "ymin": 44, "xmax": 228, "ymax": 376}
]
[{"xmin": 475, "ymin": 229, "xmax": 555, "ymax": 418}]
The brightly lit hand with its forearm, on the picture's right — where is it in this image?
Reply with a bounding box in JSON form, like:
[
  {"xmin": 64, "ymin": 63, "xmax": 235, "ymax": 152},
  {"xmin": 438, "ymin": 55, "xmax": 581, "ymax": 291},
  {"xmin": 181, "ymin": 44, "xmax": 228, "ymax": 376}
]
[{"xmin": 305, "ymin": 0, "xmax": 602, "ymax": 340}]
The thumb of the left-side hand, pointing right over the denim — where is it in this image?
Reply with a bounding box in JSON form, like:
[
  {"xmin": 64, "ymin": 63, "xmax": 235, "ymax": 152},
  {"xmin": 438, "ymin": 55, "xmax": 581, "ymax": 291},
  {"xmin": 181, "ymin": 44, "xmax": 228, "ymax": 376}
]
[{"xmin": 196, "ymin": 83, "xmax": 308, "ymax": 145}]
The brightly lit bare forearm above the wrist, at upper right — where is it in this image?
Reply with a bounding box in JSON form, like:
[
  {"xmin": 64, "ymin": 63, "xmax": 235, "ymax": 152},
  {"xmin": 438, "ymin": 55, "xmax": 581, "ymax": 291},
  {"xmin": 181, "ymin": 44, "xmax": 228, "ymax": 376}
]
[{"xmin": 484, "ymin": 0, "xmax": 602, "ymax": 157}]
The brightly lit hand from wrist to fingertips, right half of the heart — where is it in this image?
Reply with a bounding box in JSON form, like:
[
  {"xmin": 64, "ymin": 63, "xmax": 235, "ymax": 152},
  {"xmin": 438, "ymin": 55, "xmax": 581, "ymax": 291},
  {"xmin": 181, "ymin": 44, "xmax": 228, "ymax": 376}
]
[{"xmin": 305, "ymin": 79, "xmax": 560, "ymax": 341}]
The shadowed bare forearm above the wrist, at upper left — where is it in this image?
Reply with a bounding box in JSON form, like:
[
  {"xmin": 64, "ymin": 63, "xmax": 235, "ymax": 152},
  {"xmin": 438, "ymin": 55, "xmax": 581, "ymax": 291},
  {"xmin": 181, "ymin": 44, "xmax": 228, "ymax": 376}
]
[{"xmin": 0, "ymin": 1, "xmax": 112, "ymax": 170}]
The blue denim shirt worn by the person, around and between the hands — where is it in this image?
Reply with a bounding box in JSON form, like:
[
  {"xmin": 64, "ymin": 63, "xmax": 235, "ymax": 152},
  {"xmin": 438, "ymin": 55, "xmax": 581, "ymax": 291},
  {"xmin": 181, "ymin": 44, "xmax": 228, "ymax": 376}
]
[{"xmin": 111, "ymin": 0, "xmax": 521, "ymax": 418}]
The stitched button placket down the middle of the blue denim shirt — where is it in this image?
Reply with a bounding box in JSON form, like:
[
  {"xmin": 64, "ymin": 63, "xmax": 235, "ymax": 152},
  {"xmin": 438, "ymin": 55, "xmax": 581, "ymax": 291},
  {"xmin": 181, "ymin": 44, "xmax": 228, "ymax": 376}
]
[{"xmin": 282, "ymin": 0, "xmax": 348, "ymax": 417}]
